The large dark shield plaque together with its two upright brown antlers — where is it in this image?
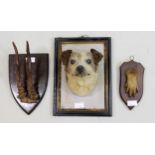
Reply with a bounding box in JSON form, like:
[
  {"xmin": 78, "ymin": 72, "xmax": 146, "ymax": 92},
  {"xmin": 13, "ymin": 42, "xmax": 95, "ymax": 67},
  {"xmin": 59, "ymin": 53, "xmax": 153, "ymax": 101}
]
[{"xmin": 9, "ymin": 41, "xmax": 48, "ymax": 114}]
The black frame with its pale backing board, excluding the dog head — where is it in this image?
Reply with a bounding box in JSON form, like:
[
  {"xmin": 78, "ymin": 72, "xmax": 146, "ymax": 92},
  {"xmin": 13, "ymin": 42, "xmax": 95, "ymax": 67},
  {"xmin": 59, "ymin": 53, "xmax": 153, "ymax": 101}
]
[{"xmin": 53, "ymin": 37, "xmax": 112, "ymax": 116}]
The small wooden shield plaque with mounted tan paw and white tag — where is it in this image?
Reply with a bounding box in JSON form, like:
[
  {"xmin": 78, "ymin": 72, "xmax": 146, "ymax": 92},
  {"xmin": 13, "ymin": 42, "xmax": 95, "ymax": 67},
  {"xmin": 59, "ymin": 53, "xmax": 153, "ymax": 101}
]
[{"xmin": 120, "ymin": 60, "xmax": 144, "ymax": 110}]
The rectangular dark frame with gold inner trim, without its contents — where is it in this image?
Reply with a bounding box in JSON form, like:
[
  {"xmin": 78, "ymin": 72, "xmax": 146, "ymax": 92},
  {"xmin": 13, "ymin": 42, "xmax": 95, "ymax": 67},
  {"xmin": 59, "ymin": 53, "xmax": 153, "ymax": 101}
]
[{"xmin": 53, "ymin": 37, "xmax": 112, "ymax": 116}]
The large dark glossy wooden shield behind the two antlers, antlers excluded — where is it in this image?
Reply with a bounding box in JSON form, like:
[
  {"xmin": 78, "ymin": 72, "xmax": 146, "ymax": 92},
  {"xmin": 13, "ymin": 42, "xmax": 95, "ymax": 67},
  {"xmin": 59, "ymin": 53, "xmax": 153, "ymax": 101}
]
[{"xmin": 9, "ymin": 54, "xmax": 49, "ymax": 114}]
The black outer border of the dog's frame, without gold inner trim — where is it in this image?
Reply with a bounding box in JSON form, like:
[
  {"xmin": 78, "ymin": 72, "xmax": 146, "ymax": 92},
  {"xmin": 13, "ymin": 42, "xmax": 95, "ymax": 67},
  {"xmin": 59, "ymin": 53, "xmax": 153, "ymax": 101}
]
[{"xmin": 53, "ymin": 37, "xmax": 112, "ymax": 116}]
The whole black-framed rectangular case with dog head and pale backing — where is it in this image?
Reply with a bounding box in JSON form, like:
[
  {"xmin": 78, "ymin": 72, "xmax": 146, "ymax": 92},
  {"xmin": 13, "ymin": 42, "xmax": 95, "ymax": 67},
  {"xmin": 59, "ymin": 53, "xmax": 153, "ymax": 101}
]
[{"xmin": 53, "ymin": 37, "xmax": 112, "ymax": 116}]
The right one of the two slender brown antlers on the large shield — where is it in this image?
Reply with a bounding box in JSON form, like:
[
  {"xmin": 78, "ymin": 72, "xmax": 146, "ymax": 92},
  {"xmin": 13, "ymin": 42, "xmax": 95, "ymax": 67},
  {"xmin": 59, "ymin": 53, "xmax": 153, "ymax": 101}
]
[{"xmin": 26, "ymin": 41, "xmax": 39, "ymax": 100}]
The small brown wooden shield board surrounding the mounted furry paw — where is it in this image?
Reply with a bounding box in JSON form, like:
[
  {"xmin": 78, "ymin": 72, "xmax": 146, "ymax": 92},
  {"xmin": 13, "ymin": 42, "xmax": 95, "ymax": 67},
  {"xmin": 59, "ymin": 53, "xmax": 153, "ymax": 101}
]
[{"xmin": 120, "ymin": 60, "xmax": 144, "ymax": 110}]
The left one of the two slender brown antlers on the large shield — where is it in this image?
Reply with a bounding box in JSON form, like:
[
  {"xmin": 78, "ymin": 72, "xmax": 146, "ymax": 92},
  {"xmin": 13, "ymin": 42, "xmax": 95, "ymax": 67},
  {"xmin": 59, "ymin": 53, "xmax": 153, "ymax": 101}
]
[{"xmin": 12, "ymin": 42, "xmax": 26, "ymax": 100}]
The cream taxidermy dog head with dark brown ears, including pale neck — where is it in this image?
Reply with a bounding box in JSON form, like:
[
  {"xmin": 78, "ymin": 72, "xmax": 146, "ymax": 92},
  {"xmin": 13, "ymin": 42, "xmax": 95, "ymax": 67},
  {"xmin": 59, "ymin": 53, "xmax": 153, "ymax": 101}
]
[{"xmin": 62, "ymin": 49, "xmax": 103, "ymax": 96}]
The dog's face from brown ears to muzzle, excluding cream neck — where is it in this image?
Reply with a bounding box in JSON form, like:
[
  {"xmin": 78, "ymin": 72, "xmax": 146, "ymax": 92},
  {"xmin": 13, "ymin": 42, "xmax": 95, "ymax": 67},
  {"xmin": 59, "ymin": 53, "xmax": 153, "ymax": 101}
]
[{"xmin": 62, "ymin": 49, "xmax": 103, "ymax": 76}]
